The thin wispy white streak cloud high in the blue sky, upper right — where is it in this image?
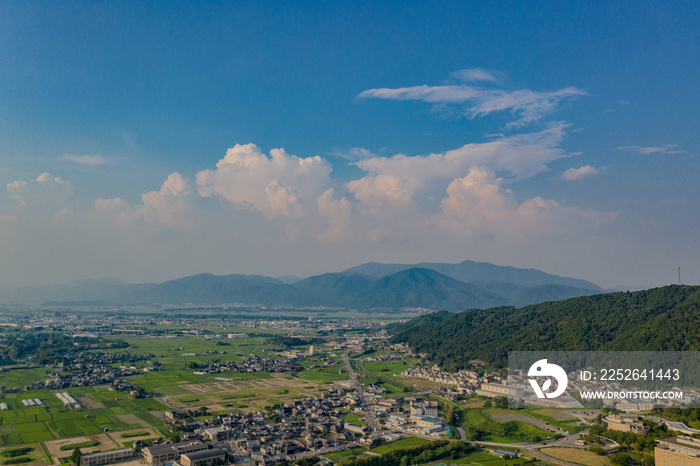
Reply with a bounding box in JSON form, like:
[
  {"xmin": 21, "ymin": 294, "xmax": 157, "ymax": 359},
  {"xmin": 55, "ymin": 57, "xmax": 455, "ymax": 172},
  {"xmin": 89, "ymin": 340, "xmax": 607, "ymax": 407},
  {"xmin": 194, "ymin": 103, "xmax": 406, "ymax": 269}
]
[{"xmin": 358, "ymin": 69, "xmax": 589, "ymax": 127}]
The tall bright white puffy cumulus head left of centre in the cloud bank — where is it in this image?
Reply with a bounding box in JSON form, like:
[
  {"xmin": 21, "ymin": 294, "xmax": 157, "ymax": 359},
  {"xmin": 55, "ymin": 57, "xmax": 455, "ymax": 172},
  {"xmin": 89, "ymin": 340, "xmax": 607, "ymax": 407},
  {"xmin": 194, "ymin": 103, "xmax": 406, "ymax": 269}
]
[{"xmin": 196, "ymin": 144, "xmax": 331, "ymax": 218}]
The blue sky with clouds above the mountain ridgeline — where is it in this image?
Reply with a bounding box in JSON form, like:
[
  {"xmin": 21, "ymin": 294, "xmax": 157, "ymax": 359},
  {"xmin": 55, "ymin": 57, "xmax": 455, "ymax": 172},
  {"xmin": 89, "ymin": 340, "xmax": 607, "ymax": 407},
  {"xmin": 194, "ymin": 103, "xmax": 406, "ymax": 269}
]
[{"xmin": 0, "ymin": 1, "xmax": 700, "ymax": 287}]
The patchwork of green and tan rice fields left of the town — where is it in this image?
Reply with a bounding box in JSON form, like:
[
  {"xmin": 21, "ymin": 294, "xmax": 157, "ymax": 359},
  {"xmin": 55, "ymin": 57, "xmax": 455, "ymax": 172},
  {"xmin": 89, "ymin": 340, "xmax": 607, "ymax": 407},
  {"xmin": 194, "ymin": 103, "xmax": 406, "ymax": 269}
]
[{"xmin": 0, "ymin": 335, "xmax": 348, "ymax": 447}]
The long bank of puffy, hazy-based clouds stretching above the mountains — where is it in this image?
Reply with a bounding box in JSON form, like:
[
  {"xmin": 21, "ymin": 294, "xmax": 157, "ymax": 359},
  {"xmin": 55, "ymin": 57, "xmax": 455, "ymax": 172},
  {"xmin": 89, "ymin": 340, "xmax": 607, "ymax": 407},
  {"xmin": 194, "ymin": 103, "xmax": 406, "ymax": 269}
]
[{"xmin": 0, "ymin": 128, "xmax": 612, "ymax": 288}]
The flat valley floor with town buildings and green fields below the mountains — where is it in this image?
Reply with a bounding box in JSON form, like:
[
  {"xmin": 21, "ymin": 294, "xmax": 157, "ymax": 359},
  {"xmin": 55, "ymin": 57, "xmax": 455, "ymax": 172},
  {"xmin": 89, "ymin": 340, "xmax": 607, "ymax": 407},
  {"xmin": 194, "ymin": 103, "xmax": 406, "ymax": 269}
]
[{"xmin": 0, "ymin": 310, "xmax": 700, "ymax": 466}]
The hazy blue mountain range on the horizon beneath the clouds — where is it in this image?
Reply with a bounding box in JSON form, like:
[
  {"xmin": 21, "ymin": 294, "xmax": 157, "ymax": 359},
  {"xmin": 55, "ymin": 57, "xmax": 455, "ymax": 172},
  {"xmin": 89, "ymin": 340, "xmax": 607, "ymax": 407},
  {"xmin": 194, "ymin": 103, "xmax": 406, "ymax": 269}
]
[{"xmin": 0, "ymin": 261, "xmax": 604, "ymax": 311}]
